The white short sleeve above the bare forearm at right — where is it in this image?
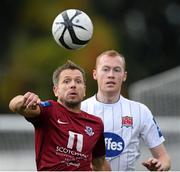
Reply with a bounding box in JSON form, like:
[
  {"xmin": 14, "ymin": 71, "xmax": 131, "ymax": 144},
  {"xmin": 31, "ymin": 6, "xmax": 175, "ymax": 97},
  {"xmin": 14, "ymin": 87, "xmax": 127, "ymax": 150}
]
[{"xmin": 141, "ymin": 105, "xmax": 165, "ymax": 148}]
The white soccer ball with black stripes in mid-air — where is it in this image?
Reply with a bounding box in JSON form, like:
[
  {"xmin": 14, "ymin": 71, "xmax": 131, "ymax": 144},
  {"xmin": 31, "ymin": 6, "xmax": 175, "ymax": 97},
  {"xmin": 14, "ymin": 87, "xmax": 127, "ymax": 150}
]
[{"xmin": 52, "ymin": 9, "xmax": 93, "ymax": 50}]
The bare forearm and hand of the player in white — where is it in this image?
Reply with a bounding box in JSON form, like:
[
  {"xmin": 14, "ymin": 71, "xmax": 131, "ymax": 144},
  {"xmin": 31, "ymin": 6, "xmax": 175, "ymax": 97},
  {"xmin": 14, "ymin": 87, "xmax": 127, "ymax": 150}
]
[{"xmin": 142, "ymin": 144, "xmax": 171, "ymax": 171}]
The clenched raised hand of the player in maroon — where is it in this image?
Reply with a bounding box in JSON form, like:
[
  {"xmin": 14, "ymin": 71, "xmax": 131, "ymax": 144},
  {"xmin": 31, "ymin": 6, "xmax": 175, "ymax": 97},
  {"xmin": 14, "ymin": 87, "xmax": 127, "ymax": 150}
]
[{"xmin": 23, "ymin": 92, "xmax": 41, "ymax": 110}]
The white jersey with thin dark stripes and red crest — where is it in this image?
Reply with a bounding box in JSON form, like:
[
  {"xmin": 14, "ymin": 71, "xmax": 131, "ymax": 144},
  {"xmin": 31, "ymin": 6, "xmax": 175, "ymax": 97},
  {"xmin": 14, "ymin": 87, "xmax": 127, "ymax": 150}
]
[{"xmin": 81, "ymin": 95, "xmax": 164, "ymax": 171}]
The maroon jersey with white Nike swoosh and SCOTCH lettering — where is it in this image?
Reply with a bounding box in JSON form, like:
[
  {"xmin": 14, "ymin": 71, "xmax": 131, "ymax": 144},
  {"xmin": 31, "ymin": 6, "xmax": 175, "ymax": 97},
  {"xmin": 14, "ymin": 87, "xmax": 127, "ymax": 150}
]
[{"xmin": 27, "ymin": 100, "xmax": 105, "ymax": 171}]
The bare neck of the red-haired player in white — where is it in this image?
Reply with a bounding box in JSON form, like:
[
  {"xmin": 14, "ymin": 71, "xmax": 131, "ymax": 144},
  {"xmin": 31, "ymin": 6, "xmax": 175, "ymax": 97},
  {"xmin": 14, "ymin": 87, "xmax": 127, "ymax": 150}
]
[{"xmin": 96, "ymin": 92, "xmax": 120, "ymax": 104}]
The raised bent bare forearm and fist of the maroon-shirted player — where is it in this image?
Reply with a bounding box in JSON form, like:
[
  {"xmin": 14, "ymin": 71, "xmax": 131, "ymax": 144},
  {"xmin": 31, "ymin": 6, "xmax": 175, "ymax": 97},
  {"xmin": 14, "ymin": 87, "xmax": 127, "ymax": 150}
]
[{"xmin": 9, "ymin": 92, "xmax": 40, "ymax": 117}]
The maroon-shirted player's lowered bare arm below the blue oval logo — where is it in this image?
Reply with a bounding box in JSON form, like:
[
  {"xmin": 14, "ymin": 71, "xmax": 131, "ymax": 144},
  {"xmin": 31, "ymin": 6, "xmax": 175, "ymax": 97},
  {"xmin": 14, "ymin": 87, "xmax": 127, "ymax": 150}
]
[{"xmin": 92, "ymin": 156, "xmax": 111, "ymax": 171}]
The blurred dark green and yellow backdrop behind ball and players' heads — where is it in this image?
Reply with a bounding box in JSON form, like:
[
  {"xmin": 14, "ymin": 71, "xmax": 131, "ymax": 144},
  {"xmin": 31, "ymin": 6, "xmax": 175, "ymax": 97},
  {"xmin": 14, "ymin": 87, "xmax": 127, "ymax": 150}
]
[{"xmin": 0, "ymin": 0, "xmax": 180, "ymax": 113}]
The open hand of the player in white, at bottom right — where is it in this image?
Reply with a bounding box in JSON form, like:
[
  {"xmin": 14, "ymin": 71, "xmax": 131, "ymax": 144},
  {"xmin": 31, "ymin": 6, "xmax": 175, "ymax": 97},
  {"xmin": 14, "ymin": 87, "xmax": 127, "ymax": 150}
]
[{"xmin": 142, "ymin": 158, "xmax": 164, "ymax": 171}]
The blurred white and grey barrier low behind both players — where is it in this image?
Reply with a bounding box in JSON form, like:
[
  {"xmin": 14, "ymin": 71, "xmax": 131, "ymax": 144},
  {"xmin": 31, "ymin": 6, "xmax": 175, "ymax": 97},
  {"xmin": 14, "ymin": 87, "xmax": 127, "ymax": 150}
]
[{"xmin": 0, "ymin": 114, "xmax": 180, "ymax": 171}]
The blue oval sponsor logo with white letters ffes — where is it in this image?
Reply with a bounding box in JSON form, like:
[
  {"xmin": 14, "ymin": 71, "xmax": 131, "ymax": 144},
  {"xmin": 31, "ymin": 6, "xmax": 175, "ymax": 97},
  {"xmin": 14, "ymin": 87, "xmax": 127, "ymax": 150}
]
[{"xmin": 104, "ymin": 132, "xmax": 125, "ymax": 158}]
